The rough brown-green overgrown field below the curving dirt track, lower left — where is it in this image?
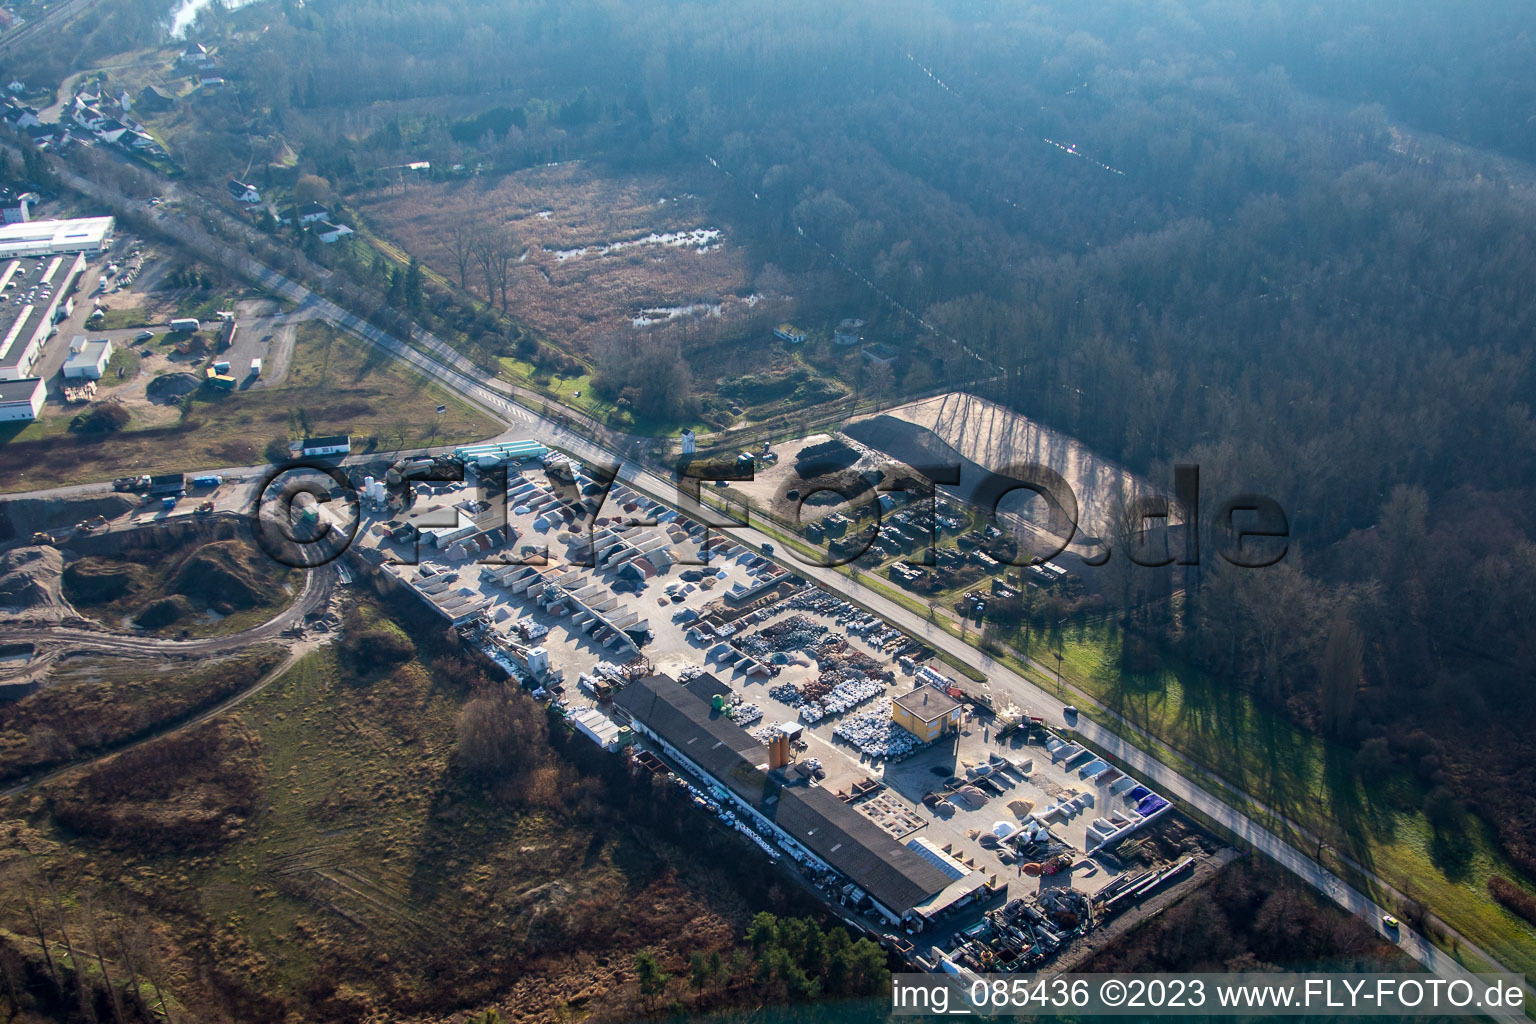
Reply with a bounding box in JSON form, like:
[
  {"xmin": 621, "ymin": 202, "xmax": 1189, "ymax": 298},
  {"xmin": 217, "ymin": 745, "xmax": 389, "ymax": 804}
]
[{"xmin": 0, "ymin": 600, "xmax": 829, "ymax": 1024}]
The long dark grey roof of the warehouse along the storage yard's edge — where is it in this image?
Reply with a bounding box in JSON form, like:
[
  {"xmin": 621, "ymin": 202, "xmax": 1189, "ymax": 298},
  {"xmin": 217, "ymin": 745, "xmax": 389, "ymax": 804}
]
[{"xmin": 614, "ymin": 674, "xmax": 951, "ymax": 913}]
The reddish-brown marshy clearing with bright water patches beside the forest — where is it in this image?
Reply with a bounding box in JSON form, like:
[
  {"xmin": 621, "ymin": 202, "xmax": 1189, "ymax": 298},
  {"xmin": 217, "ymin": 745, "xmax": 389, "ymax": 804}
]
[{"xmin": 355, "ymin": 164, "xmax": 774, "ymax": 353}]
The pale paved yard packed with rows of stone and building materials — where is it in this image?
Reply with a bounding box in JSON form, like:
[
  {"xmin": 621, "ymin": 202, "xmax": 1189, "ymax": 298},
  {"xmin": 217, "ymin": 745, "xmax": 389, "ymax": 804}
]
[{"xmin": 367, "ymin": 464, "xmax": 1144, "ymax": 892}]
